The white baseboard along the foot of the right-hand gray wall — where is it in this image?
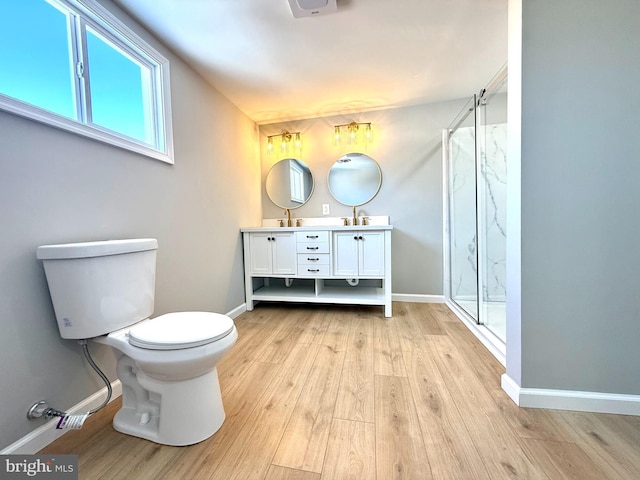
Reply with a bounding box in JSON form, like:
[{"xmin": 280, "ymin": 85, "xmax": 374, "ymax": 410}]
[{"xmin": 502, "ymin": 373, "xmax": 640, "ymax": 416}]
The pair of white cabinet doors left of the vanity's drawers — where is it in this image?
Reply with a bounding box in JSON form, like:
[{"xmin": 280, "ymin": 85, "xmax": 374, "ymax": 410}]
[{"xmin": 249, "ymin": 232, "xmax": 297, "ymax": 275}]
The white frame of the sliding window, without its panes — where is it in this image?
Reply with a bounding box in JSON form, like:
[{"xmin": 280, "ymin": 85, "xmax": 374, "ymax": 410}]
[{"xmin": 0, "ymin": 0, "xmax": 174, "ymax": 164}]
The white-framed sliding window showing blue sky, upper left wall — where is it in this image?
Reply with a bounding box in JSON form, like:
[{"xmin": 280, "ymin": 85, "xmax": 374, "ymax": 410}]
[{"xmin": 0, "ymin": 0, "xmax": 173, "ymax": 163}]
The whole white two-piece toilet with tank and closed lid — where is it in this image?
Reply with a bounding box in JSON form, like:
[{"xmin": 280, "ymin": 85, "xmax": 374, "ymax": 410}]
[{"xmin": 37, "ymin": 239, "xmax": 238, "ymax": 445}]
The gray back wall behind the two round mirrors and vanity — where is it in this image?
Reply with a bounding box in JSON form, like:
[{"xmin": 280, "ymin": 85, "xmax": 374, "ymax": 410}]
[{"xmin": 260, "ymin": 101, "xmax": 468, "ymax": 295}]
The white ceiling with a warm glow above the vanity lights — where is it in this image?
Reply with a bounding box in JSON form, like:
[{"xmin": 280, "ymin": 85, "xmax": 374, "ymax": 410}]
[{"xmin": 114, "ymin": 0, "xmax": 507, "ymax": 124}]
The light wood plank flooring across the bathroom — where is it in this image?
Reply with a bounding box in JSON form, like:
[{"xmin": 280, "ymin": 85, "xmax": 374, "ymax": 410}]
[{"xmin": 42, "ymin": 303, "xmax": 640, "ymax": 480}]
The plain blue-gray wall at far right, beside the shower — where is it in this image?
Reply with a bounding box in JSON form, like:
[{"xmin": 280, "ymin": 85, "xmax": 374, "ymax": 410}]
[{"xmin": 507, "ymin": 0, "xmax": 640, "ymax": 395}]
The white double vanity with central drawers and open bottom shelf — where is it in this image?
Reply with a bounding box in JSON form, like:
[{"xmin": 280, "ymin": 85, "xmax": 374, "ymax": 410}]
[{"xmin": 242, "ymin": 221, "xmax": 393, "ymax": 317}]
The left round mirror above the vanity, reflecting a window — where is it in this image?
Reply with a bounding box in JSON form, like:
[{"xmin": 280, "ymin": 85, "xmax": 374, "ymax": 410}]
[{"xmin": 266, "ymin": 158, "xmax": 313, "ymax": 208}]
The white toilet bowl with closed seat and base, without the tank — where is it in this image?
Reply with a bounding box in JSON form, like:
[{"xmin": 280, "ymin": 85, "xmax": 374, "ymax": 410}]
[{"xmin": 93, "ymin": 312, "xmax": 238, "ymax": 446}]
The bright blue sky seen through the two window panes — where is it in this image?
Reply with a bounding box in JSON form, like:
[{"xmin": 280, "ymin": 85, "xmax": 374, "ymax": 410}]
[{"xmin": 0, "ymin": 0, "xmax": 155, "ymax": 145}]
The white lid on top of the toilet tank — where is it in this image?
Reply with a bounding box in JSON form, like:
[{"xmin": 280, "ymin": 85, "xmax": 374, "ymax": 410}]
[{"xmin": 36, "ymin": 238, "xmax": 158, "ymax": 260}]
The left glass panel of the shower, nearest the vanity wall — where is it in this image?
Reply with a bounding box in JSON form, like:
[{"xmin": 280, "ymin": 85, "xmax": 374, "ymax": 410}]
[{"xmin": 448, "ymin": 95, "xmax": 479, "ymax": 322}]
